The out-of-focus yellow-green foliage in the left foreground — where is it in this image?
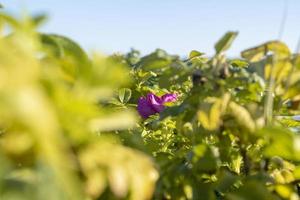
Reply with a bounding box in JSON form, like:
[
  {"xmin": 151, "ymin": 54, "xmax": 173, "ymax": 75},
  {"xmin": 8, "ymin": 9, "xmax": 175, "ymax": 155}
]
[{"xmin": 0, "ymin": 13, "xmax": 157, "ymax": 200}]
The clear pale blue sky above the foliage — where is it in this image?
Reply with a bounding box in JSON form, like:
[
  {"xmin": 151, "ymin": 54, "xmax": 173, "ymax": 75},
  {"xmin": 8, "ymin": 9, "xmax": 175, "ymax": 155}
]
[{"xmin": 0, "ymin": 0, "xmax": 300, "ymax": 56}]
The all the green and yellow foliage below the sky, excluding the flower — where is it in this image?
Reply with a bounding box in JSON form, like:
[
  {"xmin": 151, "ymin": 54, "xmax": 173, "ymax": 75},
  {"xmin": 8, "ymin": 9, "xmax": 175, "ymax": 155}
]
[{"xmin": 0, "ymin": 14, "xmax": 300, "ymax": 200}]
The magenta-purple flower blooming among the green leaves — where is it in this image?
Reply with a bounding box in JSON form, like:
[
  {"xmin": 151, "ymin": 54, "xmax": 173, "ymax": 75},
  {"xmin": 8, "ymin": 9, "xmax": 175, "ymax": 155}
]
[{"xmin": 137, "ymin": 93, "xmax": 177, "ymax": 119}]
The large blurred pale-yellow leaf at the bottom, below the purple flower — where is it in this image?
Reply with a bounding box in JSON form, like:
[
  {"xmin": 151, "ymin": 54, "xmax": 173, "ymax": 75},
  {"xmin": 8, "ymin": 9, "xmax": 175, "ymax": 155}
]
[{"xmin": 79, "ymin": 140, "xmax": 158, "ymax": 200}]
